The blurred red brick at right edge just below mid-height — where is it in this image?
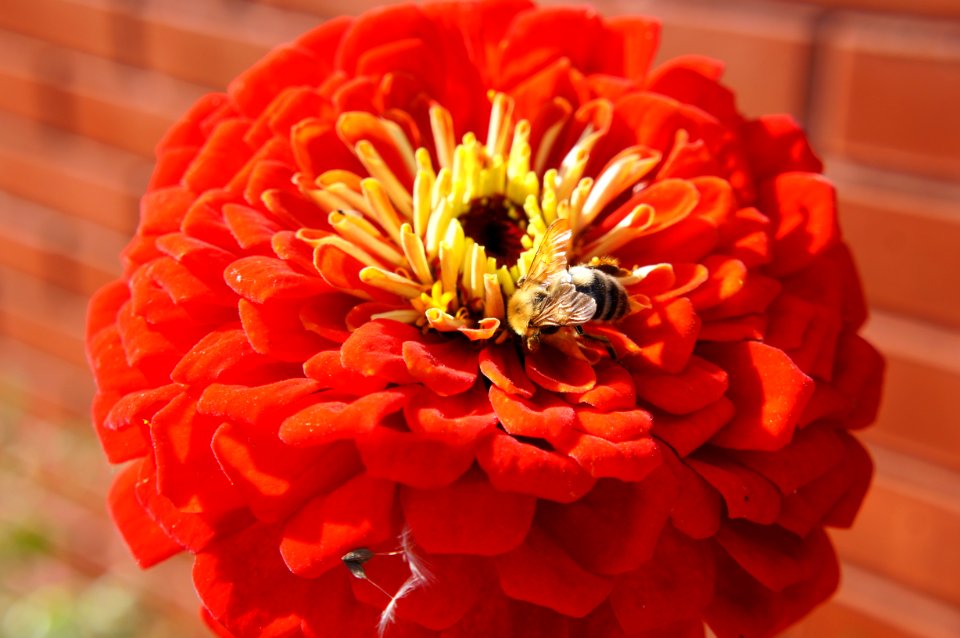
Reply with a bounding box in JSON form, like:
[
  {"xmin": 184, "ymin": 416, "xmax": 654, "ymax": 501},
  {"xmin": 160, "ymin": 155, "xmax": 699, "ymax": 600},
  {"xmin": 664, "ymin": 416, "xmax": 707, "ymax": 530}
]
[{"xmin": 863, "ymin": 313, "xmax": 960, "ymax": 471}]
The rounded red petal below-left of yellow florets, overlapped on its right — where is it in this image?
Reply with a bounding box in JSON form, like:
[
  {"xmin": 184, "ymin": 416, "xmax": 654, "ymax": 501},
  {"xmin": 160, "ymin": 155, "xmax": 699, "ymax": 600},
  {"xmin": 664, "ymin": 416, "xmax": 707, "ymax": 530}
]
[{"xmin": 340, "ymin": 319, "xmax": 422, "ymax": 384}]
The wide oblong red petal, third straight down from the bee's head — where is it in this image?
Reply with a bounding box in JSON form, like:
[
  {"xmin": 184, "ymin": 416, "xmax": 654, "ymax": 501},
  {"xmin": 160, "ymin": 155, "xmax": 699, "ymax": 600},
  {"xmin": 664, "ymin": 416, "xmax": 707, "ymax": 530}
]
[{"xmin": 477, "ymin": 436, "xmax": 594, "ymax": 503}]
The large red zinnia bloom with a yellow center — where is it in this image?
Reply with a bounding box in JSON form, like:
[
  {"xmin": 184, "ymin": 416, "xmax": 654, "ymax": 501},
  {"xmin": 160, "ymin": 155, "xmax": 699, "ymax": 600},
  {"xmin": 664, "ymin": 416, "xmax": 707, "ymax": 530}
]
[{"xmin": 88, "ymin": 0, "xmax": 882, "ymax": 638}]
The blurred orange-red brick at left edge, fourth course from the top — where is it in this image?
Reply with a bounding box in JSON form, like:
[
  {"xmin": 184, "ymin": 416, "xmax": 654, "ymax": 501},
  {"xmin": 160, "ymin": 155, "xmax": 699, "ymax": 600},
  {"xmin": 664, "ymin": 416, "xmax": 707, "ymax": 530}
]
[{"xmin": 0, "ymin": 192, "xmax": 127, "ymax": 295}]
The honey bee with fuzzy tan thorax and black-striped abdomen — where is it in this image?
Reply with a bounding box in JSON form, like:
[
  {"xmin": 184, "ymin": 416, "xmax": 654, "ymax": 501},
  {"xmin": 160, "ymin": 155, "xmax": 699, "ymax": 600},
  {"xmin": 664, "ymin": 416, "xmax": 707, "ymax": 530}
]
[{"xmin": 507, "ymin": 219, "xmax": 636, "ymax": 350}]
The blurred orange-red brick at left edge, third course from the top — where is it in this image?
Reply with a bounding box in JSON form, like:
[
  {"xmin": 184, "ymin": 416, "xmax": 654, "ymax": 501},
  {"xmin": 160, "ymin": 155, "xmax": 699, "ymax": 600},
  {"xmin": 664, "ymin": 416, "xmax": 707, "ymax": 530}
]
[{"xmin": 0, "ymin": 113, "xmax": 153, "ymax": 234}]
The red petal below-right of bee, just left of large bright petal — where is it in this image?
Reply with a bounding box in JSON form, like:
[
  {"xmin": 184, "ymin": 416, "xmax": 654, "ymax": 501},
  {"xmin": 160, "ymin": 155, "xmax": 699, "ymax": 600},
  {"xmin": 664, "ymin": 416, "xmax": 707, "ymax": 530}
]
[{"xmin": 633, "ymin": 356, "xmax": 727, "ymax": 414}]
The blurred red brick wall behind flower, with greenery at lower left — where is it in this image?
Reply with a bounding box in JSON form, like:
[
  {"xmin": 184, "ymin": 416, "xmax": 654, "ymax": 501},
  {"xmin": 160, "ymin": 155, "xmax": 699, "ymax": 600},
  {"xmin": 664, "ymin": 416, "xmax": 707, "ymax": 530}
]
[{"xmin": 0, "ymin": 0, "xmax": 960, "ymax": 638}]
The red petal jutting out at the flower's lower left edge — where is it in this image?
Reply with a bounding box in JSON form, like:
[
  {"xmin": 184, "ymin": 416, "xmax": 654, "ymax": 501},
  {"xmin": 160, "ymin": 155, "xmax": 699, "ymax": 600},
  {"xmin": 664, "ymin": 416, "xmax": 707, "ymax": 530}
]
[{"xmin": 107, "ymin": 462, "xmax": 183, "ymax": 569}]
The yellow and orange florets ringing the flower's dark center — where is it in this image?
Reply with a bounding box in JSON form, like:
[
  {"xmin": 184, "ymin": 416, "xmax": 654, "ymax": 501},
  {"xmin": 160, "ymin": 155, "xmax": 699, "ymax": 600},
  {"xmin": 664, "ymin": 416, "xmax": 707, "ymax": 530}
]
[{"xmin": 296, "ymin": 94, "xmax": 659, "ymax": 340}]
